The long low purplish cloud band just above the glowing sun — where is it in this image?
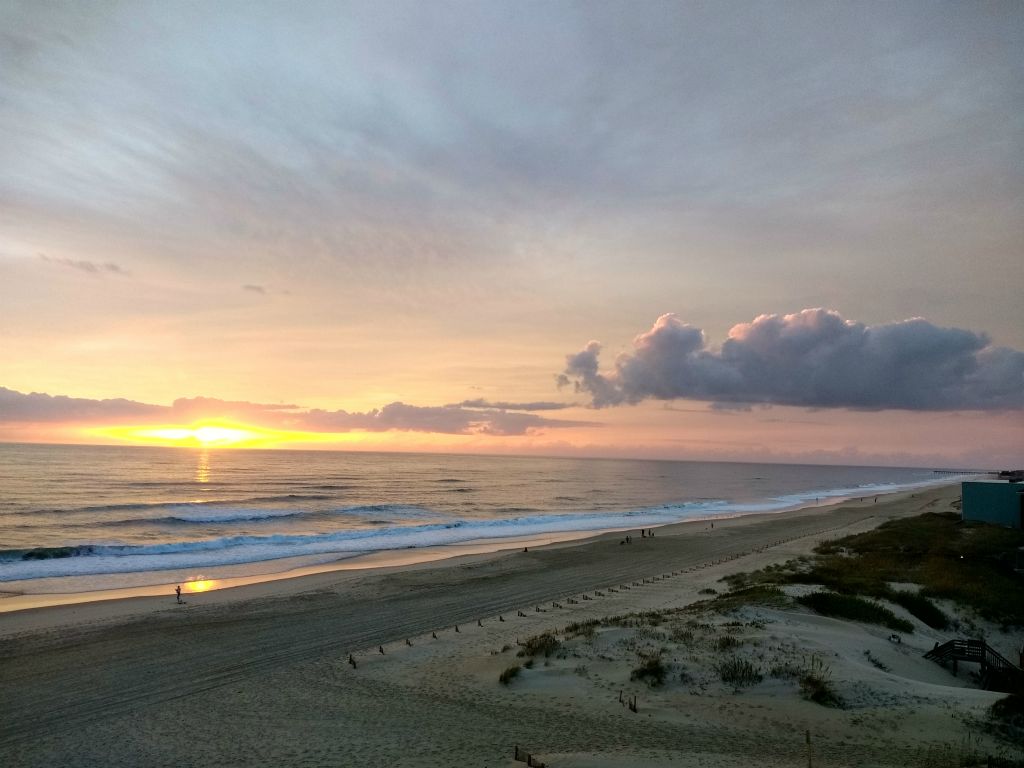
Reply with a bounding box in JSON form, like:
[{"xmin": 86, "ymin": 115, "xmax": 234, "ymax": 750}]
[{"xmin": 0, "ymin": 387, "xmax": 593, "ymax": 436}]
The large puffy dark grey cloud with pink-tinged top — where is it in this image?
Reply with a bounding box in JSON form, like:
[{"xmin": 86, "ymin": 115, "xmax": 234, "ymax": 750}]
[{"xmin": 558, "ymin": 309, "xmax": 1024, "ymax": 411}]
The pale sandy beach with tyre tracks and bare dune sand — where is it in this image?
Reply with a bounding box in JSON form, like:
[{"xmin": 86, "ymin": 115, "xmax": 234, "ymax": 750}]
[{"xmin": 0, "ymin": 485, "xmax": 1019, "ymax": 767}]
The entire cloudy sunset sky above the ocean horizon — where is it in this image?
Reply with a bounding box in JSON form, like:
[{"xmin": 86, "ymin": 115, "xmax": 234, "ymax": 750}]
[{"xmin": 0, "ymin": 0, "xmax": 1024, "ymax": 468}]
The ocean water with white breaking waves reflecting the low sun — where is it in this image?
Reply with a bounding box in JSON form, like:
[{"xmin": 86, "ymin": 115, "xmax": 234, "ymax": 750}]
[{"xmin": 0, "ymin": 444, "xmax": 950, "ymax": 592}]
